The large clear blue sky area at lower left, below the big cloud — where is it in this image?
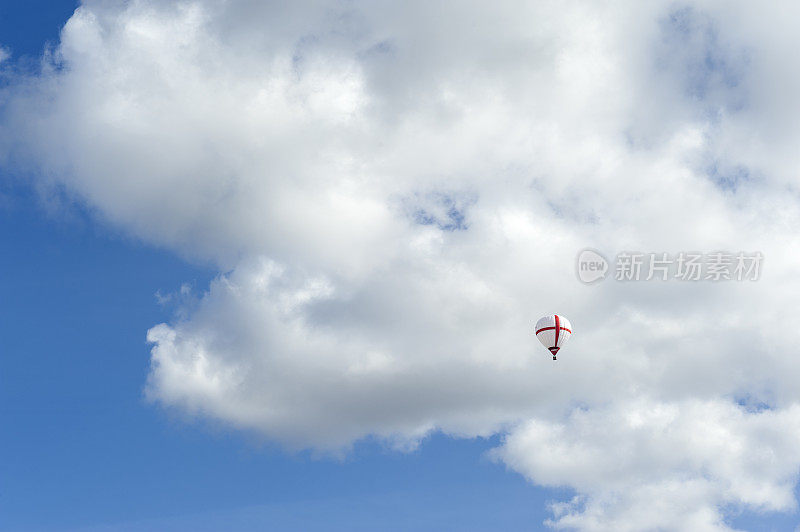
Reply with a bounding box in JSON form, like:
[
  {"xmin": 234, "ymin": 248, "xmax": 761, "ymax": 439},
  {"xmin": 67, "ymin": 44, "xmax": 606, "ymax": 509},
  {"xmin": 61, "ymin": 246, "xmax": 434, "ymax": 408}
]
[{"xmin": 0, "ymin": 181, "xmax": 547, "ymax": 530}]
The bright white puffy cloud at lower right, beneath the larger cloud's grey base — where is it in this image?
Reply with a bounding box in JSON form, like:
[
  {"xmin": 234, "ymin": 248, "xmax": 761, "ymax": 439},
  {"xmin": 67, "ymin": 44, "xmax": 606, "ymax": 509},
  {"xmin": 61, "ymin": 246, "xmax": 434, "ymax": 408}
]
[{"xmin": 494, "ymin": 398, "xmax": 800, "ymax": 531}]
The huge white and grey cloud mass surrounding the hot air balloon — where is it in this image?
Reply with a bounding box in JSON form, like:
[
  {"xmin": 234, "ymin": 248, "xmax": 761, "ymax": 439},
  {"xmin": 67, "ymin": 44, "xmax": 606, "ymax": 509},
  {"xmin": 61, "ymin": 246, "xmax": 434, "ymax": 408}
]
[{"xmin": 0, "ymin": 0, "xmax": 800, "ymax": 530}]
